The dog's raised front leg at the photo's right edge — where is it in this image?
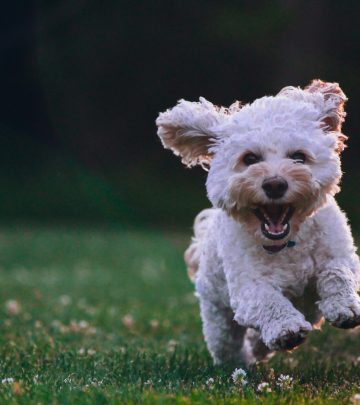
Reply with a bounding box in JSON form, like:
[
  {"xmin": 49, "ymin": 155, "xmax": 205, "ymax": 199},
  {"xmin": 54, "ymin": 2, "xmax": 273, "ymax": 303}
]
[{"xmin": 317, "ymin": 258, "xmax": 360, "ymax": 329}]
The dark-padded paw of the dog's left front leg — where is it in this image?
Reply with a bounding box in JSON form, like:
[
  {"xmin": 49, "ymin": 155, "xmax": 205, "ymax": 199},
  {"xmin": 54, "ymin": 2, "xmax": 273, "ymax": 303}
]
[{"xmin": 266, "ymin": 320, "xmax": 312, "ymax": 350}]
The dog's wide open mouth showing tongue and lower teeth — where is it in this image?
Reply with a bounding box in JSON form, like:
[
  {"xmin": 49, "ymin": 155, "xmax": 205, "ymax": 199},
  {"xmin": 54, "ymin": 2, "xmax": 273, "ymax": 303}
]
[{"xmin": 254, "ymin": 204, "xmax": 295, "ymax": 240}]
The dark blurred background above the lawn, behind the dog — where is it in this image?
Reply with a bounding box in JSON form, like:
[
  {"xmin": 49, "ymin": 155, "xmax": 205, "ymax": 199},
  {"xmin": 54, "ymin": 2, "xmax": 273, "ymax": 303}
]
[{"xmin": 0, "ymin": 0, "xmax": 360, "ymax": 229}]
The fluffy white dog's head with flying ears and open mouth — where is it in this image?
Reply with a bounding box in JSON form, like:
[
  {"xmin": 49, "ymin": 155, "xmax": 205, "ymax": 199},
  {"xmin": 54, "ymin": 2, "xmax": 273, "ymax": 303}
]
[{"xmin": 156, "ymin": 80, "xmax": 347, "ymax": 252}]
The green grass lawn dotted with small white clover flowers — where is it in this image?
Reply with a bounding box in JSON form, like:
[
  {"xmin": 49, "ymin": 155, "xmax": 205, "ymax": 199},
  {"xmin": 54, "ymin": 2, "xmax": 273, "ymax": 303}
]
[{"xmin": 0, "ymin": 226, "xmax": 360, "ymax": 404}]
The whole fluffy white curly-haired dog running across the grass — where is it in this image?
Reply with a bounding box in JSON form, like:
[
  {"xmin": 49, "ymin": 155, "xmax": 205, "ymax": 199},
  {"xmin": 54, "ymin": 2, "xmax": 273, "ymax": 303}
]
[{"xmin": 157, "ymin": 80, "xmax": 360, "ymax": 364}]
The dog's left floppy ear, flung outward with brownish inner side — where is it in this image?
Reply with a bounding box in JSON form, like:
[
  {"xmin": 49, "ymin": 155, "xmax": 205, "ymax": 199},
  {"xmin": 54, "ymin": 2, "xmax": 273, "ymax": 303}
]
[{"xmin": 156, "ymin": 97, "xmax": 238, "ymax": 167}]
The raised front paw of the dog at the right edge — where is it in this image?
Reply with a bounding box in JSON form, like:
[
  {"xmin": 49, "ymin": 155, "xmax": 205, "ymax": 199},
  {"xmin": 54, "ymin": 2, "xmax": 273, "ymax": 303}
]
[{"xmin": 319, "ymin": 296, "xmax": 360, "ymax": 329}]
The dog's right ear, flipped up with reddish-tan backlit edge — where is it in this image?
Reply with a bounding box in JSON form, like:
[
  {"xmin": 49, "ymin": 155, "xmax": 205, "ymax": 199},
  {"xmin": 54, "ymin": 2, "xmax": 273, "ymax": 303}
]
[{"xmin": 305, "ymin": 80, "xmax": 347, "ymax": 153}]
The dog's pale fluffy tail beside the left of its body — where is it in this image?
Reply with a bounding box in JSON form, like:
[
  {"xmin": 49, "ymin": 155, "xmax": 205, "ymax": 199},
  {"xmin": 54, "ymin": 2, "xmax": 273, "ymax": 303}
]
[{"xmin": 184, "ymin": 208, "xmax": 216, "ymax": 281}]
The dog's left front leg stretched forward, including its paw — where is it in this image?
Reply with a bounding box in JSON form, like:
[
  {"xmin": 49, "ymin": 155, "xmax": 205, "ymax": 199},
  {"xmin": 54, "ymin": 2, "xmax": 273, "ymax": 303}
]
[{"xmin": 231, "ymin": 282, "xmax": 312, "ymax": 350}]
